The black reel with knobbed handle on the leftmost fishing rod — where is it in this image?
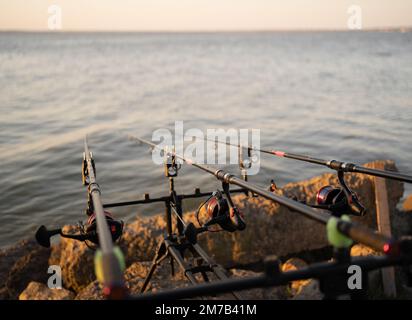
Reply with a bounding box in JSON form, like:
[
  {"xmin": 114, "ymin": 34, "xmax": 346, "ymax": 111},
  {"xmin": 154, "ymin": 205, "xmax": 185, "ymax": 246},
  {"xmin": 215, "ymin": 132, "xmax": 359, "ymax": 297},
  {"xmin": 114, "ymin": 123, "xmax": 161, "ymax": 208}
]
[{"xmin": 35, "ymin": 211, "xmax": 124, "ymax": 249}]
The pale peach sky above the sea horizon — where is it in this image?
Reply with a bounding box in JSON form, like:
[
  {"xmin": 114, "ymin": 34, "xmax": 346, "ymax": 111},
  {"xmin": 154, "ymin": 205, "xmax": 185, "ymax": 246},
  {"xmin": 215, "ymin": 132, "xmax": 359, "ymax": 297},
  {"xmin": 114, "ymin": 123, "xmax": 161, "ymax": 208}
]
[{"xmin": 0, "ymin": 0, "xmax": 412, "ymax": 31}]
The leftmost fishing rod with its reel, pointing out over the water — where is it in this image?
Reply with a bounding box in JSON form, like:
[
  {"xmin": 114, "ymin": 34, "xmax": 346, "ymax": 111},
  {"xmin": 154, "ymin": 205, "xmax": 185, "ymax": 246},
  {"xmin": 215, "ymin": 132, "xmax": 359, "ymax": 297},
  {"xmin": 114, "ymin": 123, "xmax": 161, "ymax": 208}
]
[{"xmin": 36, "ymin": 137, "xmax": 127, "ymax": 299}]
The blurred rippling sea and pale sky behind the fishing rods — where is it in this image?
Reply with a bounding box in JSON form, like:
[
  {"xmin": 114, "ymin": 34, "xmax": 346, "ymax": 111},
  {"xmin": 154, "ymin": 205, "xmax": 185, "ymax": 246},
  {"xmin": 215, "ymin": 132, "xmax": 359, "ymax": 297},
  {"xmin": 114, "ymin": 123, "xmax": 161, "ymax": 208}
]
[{"xmin": 0, "ymin": 0, "xmax": 412, "ymax": 247}]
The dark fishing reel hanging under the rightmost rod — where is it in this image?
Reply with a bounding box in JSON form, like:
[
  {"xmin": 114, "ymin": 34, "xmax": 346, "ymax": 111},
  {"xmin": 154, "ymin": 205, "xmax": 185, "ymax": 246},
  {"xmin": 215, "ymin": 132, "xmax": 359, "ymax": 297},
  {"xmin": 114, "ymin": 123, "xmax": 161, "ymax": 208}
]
[{"xmin": 313, "ymin": 171, "xmax": 366, "ymax": 217}]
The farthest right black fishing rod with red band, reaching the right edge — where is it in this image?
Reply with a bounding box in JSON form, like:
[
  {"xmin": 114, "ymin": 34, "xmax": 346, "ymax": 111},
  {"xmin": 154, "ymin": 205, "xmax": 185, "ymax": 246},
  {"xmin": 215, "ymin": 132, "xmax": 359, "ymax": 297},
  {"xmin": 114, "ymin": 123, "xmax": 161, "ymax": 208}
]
[{"xmin": 203, "ymin": 138, "xmax": 412, "ymax": 183}]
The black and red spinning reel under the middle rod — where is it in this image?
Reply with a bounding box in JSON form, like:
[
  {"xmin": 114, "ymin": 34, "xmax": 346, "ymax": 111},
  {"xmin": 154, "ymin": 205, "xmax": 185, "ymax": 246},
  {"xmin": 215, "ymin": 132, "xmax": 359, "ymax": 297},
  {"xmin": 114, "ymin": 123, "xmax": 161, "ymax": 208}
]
[{"xmin": 184, "ymin": 182, "xmax": 246, "ymax": 243}]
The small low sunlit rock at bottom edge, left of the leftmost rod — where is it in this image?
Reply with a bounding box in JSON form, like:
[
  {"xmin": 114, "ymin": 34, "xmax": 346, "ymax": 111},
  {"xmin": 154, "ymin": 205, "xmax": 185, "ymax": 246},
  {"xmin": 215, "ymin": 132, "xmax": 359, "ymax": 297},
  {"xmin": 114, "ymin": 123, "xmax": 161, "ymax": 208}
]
[{"xmin": 19, "ymin": 281, "xmax": 74, "ymax": 300}]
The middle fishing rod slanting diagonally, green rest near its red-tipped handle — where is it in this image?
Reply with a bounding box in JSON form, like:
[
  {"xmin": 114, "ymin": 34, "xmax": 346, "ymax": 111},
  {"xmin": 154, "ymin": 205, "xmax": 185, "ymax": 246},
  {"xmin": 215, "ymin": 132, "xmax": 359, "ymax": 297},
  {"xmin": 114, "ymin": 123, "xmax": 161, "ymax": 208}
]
[{"xmin": 129, "ymin": 135, "xmax": 404, "ymax": 255}]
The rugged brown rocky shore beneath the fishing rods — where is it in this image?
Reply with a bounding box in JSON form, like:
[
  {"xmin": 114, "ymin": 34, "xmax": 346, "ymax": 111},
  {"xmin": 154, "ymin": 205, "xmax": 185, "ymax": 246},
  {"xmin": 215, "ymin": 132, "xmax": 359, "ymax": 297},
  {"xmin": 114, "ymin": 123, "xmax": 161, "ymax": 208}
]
[{"xmin": 0, "ymin": 161, "xmax": 412, "ymax": 300}]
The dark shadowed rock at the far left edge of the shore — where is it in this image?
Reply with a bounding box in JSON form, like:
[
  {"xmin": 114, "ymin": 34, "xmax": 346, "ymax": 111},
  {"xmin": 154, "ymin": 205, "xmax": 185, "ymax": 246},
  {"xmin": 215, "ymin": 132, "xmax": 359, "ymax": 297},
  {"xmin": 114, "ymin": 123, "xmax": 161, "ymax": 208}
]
[{"xmin": 0, "ymin": 240, "xmax": 50, "ymax": 299}]
